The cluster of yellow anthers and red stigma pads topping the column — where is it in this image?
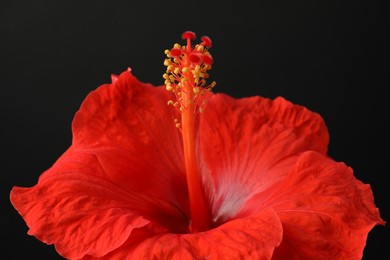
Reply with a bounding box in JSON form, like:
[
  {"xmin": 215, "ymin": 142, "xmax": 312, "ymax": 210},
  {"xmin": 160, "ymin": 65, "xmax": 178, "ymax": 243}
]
[{"xmin": 163, "ymin": 31, "xmax": 216, "ymax": 122}]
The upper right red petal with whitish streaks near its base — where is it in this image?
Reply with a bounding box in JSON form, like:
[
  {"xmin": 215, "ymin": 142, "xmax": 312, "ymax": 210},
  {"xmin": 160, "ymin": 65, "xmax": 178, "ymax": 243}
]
[{"xmin": 199, "ymin": 94, "xmax": 329, "ymax": 223}]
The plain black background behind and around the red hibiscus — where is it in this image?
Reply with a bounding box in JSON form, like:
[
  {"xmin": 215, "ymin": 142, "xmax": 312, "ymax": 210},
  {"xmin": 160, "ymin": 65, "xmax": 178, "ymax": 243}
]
[{"xmin": 0, "ymin": 0, "xmax": 390, "ymax": 259}]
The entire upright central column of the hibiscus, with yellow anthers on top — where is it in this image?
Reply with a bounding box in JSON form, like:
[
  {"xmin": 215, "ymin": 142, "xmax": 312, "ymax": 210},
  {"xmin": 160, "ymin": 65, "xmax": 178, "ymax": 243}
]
[{"xmin": 163, "ymin": 31, "xmax": 216, "ymax": 232}]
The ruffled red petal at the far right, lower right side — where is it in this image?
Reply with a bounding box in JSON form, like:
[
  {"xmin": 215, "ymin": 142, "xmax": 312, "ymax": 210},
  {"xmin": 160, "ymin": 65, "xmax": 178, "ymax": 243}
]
[{"xmin": 243, "ymin": 152, "xmax": 384, "ymax": 259}]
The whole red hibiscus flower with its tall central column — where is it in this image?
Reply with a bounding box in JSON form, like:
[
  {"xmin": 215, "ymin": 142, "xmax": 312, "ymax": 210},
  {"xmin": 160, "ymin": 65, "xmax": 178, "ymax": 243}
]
[{"xmin": 11, "ymin": 32, "xmax": 385, "ymax": 259}]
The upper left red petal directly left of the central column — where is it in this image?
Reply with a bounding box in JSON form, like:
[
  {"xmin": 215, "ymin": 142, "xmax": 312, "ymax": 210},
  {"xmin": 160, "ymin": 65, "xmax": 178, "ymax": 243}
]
[{"xmin": 73, "ymin": 68, "xmax": 188, "ymax": 215}]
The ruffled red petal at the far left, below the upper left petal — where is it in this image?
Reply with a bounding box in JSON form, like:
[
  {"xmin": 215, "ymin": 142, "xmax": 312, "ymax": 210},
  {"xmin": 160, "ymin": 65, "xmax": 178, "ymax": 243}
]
[{"xmin": 10, "ymin": 147, "xmax": 186, "ymax": 259}]
